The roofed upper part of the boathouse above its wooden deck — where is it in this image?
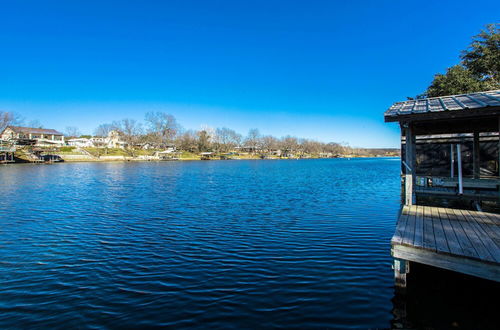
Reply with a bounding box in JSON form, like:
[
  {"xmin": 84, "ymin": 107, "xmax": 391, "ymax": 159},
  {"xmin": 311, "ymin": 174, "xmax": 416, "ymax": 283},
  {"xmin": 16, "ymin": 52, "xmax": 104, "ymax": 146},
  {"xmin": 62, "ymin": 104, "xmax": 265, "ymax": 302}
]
[{"xmin": 386, "ymin": 92, "xmax": 500, "ymax": 208}]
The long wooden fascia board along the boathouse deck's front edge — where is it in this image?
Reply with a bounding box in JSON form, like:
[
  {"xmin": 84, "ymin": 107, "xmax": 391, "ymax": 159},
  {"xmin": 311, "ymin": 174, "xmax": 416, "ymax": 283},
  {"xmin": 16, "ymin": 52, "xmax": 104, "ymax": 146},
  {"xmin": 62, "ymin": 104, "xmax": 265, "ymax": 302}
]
[{"xmin": 392, "ymin": 245, "xmax": 500, "ymax": 282}]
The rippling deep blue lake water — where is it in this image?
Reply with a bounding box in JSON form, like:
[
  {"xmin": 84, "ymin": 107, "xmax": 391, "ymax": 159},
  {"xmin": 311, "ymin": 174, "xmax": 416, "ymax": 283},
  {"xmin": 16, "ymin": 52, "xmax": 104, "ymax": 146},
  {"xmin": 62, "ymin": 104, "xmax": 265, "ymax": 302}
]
[{"xmin": 0, "ymin": 159, "xmax": 400, "ymax": 328}]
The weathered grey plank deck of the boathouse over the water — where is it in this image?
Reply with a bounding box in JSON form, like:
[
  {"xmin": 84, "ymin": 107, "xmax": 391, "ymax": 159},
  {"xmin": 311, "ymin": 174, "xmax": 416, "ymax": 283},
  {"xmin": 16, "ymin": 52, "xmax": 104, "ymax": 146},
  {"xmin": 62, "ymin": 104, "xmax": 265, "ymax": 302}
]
[{"xmin": 391, "ymin": 205, "xmax": 500, "ymax": 282}]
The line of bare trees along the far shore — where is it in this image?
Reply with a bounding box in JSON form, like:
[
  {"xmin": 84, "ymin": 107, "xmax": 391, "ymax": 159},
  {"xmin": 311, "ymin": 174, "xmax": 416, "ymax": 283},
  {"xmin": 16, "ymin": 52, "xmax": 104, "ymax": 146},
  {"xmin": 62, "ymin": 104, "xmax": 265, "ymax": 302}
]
[{"xmin": 0, "ymin": 111, "xmax": 394, "ymax": 156}]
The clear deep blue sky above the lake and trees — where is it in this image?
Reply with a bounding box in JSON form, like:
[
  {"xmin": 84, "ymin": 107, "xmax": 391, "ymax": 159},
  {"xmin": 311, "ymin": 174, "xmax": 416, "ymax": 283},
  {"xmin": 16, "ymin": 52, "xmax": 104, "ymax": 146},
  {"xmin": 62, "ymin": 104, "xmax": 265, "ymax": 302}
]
[{"xmin": 0, "ymin": 0, "xmax": 500, "ymax": 147}]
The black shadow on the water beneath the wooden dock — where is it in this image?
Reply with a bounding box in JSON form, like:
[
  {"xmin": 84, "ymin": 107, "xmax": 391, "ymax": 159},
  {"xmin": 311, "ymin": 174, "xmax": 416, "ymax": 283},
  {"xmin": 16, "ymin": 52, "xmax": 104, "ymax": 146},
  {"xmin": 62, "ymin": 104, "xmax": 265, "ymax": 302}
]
[{"xmin": 391, "ymin": 263, "xmax": 500, "ymax": 329}]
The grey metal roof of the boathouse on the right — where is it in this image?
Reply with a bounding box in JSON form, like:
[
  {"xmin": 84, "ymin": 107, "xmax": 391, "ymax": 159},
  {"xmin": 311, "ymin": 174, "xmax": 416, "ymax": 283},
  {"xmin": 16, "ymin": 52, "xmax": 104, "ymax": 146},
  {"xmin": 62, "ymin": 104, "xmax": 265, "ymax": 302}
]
[{"xmin": 384, "ymin": 90, "xmax": 500, "ymax": 121}]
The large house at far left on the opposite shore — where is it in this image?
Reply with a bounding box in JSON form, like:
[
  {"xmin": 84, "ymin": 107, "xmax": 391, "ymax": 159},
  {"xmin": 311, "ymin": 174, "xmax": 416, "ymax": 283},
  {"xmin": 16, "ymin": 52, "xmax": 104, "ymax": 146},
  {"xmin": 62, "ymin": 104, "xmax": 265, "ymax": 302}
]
[{"xmin": 0, "ymin": 126, "xmax": 65, "ymax": 147}]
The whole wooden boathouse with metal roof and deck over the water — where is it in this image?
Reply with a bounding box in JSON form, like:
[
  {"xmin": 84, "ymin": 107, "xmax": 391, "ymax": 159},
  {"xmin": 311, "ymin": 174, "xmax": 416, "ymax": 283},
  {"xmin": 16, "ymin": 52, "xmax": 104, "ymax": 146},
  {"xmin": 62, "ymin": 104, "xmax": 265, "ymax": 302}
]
[{"xmin": 384, "ymin": 90, "xmax": 500, "ymax": 288}]
